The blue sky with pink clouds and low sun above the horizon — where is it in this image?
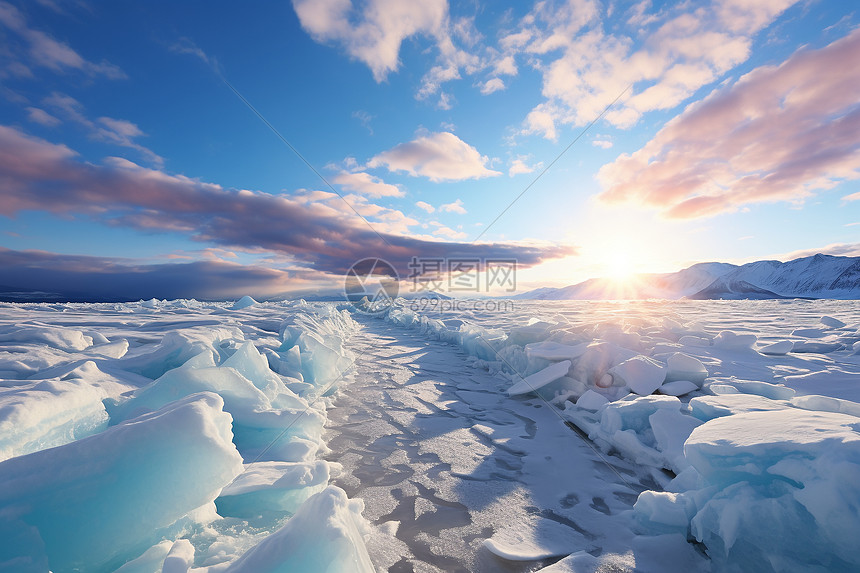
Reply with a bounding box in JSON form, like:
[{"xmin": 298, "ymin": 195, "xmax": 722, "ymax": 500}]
[{"xmin": 0, "ymin": 0, "xmax": 860, "ymax": 298}]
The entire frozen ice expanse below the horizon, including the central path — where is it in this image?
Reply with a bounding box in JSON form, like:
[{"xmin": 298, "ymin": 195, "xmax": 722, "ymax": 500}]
[{"xmin": 0, "ymin": 299, "xmax": 860, "ymax": 573}]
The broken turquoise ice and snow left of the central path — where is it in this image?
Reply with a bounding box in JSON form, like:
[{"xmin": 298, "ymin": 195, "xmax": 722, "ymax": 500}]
[{"xmin": 0, "ymin": 300, "xmax": 363, "ymax": 573}]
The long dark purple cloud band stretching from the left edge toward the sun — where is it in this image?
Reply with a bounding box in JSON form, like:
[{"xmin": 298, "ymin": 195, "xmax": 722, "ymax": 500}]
[{"xmin": 0, "ymin": 126, "xmax": 575, "ymax": 275}]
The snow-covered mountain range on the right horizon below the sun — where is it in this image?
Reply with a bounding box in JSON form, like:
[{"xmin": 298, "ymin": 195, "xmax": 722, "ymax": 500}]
[{"xmin": 515, "ymin": 254, "xmax": 860, "ymax": 300}]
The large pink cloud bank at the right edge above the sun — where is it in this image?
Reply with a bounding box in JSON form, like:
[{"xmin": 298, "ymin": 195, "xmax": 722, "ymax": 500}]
[{"xmin": 598, "ymin": 29, "xmax": 860, "ymax": 218}]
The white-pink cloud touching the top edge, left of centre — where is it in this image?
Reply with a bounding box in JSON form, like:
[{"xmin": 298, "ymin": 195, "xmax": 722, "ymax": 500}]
[{"xmin": 293, "ymin": 0, "xmax": 448, "ymax": 82}]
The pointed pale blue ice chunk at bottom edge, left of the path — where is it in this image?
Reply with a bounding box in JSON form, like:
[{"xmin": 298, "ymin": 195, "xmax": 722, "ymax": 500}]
[{"xmin": 225, "ymin": 486, "xmax": 375, "ymax": 573}]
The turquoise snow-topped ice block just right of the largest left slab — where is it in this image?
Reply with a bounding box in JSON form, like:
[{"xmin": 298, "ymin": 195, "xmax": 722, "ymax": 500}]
[{"xmin": 215, "ymin": 460, "xmax": 329, "ymax": 517}]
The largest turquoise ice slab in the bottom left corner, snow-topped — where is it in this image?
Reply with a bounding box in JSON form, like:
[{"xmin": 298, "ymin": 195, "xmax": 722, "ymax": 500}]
[{"xmin": 0, "ymin": 394, "xmax": 242, "ymax": 571}]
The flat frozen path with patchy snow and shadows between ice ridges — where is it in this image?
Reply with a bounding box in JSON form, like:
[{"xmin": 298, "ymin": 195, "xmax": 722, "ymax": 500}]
[{"xmin": 325, "ymin": 316, "xmax": 668, "ymax": 573}]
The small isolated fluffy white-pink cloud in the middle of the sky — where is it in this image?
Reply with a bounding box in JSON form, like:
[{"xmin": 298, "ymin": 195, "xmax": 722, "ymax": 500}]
[{"xmin": 367, "ymin": 132, "xmax": 501, "ymax": 181}]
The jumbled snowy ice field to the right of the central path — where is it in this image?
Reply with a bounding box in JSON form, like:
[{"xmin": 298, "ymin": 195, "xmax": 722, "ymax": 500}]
[{"xmin": 366, "ymin": 301, "xmax": 860, "ymax": 572}]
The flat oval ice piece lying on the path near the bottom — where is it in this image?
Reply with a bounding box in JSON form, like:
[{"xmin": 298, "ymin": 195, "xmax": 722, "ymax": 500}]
[{"xmin": 484, "ymin": 518, "xmax": 591, "ymax": 561}]
